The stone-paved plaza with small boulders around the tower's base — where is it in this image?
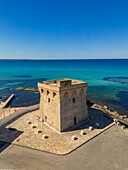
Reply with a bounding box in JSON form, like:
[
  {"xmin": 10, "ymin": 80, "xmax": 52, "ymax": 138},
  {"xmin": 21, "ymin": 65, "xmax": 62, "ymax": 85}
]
[{"xmin": 0, "ymin": 109, "xmax": 113, "ymax": 154}]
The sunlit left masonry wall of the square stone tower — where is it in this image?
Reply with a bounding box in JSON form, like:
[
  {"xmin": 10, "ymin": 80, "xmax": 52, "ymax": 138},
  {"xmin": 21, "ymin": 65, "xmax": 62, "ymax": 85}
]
[{"xmin": 39, "ymin": 85, "xmax": 61, "ymax": 131}]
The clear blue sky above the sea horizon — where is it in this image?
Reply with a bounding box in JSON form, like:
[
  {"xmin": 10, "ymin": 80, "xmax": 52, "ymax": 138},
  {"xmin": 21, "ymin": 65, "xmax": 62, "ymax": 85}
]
[{"xmin": 0, "ymin": 0, "xmax": 128, "ymax": 59}]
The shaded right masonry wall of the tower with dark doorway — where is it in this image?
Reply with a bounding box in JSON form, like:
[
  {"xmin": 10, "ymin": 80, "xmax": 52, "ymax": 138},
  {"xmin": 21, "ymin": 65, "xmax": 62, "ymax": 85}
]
[{"xmin": 60, "ymin": 86, "xmax": 88, "ymax": 131}]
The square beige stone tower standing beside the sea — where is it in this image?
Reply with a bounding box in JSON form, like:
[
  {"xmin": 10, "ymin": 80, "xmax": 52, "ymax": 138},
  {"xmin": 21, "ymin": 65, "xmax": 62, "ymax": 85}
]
[{"xmin": 38, "ymin": 78, "xmax": 88, "ymax": 132}]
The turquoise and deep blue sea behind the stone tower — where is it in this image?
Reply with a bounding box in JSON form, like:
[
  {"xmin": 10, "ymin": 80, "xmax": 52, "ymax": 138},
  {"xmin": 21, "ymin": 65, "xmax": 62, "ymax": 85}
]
[{"xmin": 0, "ymin": 59, "xmax": 128, "ymax": 114}]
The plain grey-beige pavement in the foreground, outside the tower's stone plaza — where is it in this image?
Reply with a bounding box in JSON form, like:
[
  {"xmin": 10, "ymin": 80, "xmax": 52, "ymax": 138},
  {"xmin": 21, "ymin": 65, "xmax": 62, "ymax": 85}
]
[{"xmin": 0, "ymin": 126, "xmax": 128, "ymax": 170}]
